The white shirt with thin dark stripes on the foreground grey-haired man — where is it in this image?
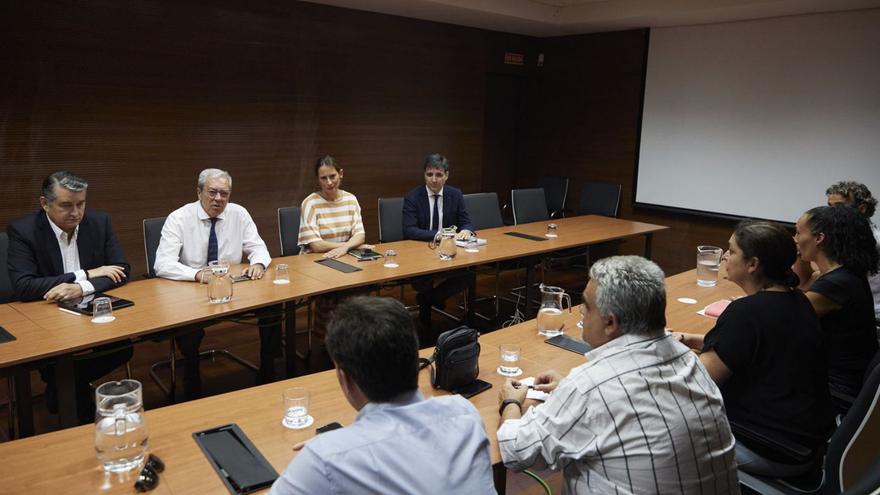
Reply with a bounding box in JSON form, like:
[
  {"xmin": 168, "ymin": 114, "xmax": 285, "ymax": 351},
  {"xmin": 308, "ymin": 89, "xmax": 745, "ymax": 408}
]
[{"xmin": 498, "ymin": 334, "xmax": 739, "ymax": 494}]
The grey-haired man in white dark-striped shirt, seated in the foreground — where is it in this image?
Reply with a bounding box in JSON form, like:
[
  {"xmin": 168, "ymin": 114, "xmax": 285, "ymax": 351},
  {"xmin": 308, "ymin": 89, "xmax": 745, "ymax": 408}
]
[{"xmin": 498, "ymin": 256, "xmax": 739, "ymax": 494}]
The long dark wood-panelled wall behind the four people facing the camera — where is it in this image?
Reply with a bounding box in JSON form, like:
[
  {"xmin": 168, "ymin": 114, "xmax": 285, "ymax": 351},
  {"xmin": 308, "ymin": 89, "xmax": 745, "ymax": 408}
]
[{"xmin": 0, "ymin": 0, "xmax": 531, "ymax": 280}]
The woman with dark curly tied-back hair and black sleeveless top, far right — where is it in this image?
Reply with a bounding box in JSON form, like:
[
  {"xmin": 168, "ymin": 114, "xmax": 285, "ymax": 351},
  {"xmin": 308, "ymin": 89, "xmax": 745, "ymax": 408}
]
[{"xmin": 795, "ymin": 204, "xmax": 878, "ymax": 397}]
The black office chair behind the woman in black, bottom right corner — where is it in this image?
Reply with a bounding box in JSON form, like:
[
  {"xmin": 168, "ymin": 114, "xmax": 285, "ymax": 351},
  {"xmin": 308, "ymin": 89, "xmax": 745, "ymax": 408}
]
[{"xmin": 731, "ymin": 359, "xmax": 880, "ymax": 493}]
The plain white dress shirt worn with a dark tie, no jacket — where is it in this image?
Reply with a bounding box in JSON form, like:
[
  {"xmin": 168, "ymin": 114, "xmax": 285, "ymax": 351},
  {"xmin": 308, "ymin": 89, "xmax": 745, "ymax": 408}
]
[{"xmin": 153, "ymin": 201, "xmax": 272, "ymax": 280}]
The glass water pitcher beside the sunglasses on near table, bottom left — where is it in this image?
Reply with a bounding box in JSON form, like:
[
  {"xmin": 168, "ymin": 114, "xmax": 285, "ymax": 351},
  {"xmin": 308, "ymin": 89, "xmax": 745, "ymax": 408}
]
[{"xmin": 95, "ymin": 380, "xmax": 148, "ymax": 473}]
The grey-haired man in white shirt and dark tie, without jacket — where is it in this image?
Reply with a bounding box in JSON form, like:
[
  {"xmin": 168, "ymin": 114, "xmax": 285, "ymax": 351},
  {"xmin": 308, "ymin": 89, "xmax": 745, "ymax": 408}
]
[{"xmin": 153, "ymin": 168, "xmax": 281, "ymax": 398}]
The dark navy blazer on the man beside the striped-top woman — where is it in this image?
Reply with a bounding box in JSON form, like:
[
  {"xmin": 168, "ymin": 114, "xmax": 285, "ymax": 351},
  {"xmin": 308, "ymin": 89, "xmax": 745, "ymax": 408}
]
[{"xmin": 403, "ymin": 185, "xmax": 474, "ymax": 241}]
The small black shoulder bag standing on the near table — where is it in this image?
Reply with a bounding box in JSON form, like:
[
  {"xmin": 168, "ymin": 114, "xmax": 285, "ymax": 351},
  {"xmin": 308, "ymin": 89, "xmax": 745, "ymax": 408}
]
[{"xmin": 419, "ymin": 326, "xmax": 480, "ymax": 392}]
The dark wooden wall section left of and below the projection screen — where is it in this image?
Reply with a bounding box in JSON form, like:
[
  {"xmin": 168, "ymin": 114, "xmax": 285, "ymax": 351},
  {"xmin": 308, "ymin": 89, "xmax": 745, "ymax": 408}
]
[{"xmin": 516, "ymin": 30, "xmax": 734, "ymax": 274}]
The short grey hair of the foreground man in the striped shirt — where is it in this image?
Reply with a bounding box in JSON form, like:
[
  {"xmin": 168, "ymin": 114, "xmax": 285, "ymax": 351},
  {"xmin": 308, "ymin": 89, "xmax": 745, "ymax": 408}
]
[{"xmin": 590, "ymin": 256, "xmax": 666, "ymax": 334}]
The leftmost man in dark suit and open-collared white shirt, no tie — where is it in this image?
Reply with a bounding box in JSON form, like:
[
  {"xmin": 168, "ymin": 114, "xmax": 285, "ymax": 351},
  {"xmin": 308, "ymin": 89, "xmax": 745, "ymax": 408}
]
[{"xmin": 6, "ymin": 172, "xmax": 132, "ymax": 423}]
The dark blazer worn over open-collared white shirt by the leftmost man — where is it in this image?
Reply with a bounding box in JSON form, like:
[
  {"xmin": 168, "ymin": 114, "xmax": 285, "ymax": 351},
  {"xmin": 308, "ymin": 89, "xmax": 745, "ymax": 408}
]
[{"xmin": 6, "ymin": 209, "xmax": 131, "ymax": 301}]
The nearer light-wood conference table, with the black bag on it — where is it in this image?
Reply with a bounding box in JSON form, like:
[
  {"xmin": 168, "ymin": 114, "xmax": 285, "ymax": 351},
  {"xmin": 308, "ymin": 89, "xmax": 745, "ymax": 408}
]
[{"xmin": 0, "ymin": 270, "xmax": 743, "ymax": 494}]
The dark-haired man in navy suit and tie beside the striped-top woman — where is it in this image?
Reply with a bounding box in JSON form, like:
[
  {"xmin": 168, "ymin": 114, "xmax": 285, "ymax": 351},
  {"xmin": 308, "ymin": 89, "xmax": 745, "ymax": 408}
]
[{"xmin": 403, "ymin": 153, "xmax": 474, "ymax": 343}]
